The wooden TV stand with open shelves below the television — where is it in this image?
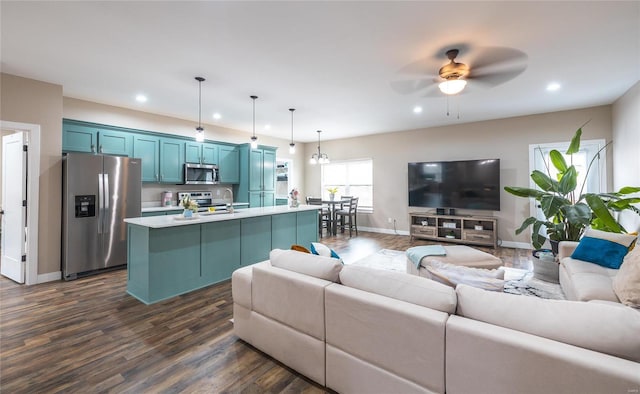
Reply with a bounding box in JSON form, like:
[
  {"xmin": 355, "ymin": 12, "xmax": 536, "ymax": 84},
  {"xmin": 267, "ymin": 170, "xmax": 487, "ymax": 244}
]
[{"xmin": 409, "ymin": 212, "xmax": 498, "ymax": 248}]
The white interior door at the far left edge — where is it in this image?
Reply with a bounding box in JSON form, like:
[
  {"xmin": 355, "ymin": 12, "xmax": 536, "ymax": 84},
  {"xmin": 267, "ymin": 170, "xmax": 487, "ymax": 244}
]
[{"xmin": 0, "ymin": 132, "xmax": 27, "ymax": 283}]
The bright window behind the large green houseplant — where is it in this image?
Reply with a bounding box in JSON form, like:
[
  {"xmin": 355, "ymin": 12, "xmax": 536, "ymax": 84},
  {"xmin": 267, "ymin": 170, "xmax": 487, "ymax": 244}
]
[{"xmin": 529, "ymin": 139, "xmax": 607, "ymax": 220}]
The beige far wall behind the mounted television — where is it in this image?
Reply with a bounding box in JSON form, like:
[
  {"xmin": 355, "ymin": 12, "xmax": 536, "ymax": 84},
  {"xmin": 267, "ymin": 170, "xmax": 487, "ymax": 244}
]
[{"xmin": 305, "ymin": 106, "xmax": 611, "ymax": 243}]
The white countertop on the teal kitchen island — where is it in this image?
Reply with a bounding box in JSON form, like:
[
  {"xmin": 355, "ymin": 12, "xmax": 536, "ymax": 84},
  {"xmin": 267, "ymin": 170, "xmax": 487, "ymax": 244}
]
[{"xmin": 124, "ymin": 205, "xmax": 322, "ymax": 228}]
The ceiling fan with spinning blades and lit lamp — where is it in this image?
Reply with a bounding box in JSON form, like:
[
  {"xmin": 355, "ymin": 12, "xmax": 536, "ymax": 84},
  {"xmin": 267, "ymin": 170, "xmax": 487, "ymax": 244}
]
[{"xmin": 391, "ymin": 44, "xmax": 528, "ymax": 97}]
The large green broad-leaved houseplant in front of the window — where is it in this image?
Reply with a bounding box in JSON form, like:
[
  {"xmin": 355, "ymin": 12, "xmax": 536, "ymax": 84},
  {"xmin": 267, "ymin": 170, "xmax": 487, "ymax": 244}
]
[{"xmin": 504, "ymin": 125, "xmax": 640, "ymax": 249}]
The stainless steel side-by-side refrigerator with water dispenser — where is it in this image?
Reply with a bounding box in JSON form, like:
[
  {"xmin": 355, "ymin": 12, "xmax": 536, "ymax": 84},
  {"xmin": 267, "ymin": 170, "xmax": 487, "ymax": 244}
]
[{"xmin": 62, "ymin": 153, "xmax": 142, "ymax": 280}]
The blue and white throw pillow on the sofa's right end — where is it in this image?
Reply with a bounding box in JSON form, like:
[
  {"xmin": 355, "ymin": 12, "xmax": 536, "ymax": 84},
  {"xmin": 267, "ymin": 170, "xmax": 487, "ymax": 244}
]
[{"xmin": 571, "ymin": 228, "xmax": 637, "ymax": 269}]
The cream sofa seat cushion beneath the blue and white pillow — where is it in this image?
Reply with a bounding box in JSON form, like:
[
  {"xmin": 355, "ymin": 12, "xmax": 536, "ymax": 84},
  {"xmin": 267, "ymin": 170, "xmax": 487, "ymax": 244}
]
[{"xmin": 560, "ymin": 257, "xmax": 618, "ymax": 302}]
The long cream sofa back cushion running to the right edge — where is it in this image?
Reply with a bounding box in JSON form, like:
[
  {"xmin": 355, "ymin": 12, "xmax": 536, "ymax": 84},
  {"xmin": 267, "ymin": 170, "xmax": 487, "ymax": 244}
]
[{"xmin": 456, "ymin": 285, "xmax": 640, "ymax": 362}]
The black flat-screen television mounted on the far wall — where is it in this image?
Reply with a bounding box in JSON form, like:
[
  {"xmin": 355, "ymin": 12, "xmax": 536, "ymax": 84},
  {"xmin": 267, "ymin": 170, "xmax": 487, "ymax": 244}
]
[{"xmin": 409, "ymin": 159, "xmax": 500, "ymax": 211}]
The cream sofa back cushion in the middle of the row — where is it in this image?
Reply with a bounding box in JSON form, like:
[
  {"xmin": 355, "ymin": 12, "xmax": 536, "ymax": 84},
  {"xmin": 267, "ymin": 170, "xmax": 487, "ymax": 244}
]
[{"xmin": 340, "ymin": 265, "xmax": 456, "ymax": 314}]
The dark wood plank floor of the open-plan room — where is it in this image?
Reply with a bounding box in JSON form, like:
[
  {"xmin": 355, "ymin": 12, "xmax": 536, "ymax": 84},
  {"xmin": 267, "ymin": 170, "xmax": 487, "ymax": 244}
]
[{"xmin": 0, "ymin": 232, "xmax": 530, "ymax": 393}]
